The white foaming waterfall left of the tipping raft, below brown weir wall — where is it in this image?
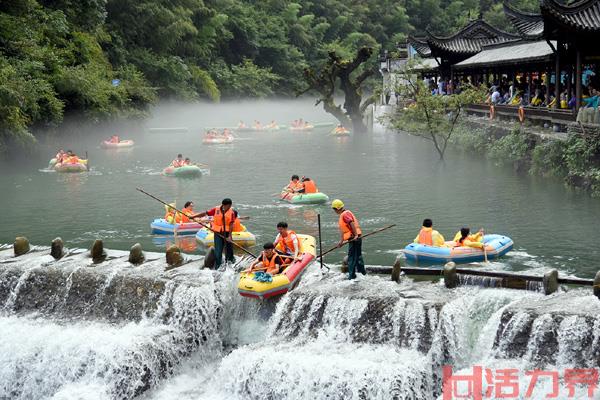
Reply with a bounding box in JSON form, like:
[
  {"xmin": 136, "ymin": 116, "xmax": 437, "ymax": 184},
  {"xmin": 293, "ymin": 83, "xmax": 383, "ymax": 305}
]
[{"xmin": 0, "ymin": 266, "xmax": 222, "ymax": 399}]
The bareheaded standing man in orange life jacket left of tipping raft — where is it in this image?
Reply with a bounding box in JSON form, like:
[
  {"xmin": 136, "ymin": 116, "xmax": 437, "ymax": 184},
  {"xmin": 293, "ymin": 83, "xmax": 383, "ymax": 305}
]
[{"xmin": 194, "ymin": 199, "xmax": 238, "ymax": 268}]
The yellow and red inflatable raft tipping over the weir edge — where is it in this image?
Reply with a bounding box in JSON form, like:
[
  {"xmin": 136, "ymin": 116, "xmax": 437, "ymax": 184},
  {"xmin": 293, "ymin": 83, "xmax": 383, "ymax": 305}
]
[{"xmin": 238, "ymin": 235, "xmax": 316, "ymax": 299}]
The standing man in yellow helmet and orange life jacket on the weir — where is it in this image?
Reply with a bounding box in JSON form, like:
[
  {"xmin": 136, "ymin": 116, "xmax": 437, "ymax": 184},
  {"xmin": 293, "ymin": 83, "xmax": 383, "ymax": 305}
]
[{"xmin": 331, "ymin": 199, "xmax": 367, "ymax": 280}]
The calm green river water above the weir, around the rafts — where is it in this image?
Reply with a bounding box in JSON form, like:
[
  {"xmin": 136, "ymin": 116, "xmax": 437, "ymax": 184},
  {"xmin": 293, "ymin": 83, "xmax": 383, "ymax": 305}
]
[{"xmin": 0, "ymin": 101, "xmax": 600, "ymax": 277}]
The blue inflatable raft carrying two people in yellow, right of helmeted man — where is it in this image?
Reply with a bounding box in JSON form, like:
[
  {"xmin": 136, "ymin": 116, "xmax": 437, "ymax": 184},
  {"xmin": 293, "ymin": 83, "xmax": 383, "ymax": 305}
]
[{"xmin": 403, "ymin": 235, "xmax": 514, "ymax": 264}]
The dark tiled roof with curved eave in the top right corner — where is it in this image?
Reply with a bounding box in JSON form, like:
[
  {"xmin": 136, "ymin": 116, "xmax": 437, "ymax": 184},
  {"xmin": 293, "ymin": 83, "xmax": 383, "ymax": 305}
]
[{"xmin": 540, "ymin": 0, "xmax": 600, "ymax": 33}]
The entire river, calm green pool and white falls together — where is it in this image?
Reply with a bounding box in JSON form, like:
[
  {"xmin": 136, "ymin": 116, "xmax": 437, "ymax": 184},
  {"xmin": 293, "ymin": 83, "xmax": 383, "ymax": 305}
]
[{"xmin": 0, "ymin": 101, "xmax": 600, "ymax": 400}]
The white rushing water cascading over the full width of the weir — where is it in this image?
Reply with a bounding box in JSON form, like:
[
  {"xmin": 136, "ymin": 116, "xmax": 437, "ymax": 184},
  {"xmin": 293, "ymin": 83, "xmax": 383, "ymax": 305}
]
[{"xmin": 0, "ymin": 260, "xmax": 600, "ymax": 400}]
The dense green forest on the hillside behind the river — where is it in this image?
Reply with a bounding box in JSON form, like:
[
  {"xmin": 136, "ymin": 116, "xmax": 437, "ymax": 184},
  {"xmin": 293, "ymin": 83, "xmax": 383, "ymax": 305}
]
[{"xmin": 0, "ymin": 0, "xmax": 538, "ymax": 152}]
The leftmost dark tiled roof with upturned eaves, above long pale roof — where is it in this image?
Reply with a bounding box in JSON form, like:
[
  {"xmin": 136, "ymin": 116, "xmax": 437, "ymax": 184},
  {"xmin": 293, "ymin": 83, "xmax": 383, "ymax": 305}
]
[{"xmin": 427, "ymin": 19, "xmax": 519, "ymax": 55}]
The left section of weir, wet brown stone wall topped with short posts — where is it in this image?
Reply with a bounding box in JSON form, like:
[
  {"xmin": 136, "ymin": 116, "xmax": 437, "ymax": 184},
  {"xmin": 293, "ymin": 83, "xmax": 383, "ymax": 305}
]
[{"xmin": 0, "ymin": 242, "xmax": 211, "ymax": 321}]
